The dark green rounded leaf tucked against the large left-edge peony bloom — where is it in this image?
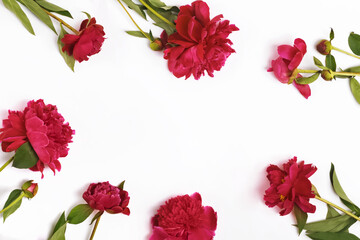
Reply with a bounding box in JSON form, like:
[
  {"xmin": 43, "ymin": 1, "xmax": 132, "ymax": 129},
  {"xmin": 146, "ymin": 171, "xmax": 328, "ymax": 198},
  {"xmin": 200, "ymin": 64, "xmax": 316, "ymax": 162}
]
[{"xmin": 13, "ymin": 142, "xmax": 39, "ymax": 168}]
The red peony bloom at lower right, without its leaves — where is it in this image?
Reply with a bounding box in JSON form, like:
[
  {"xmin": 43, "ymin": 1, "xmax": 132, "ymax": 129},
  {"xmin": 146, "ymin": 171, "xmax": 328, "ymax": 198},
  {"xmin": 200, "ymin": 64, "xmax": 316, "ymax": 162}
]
[{"xmin": 264, "ymin": 157, "xmax": 317, "ymax": 216}]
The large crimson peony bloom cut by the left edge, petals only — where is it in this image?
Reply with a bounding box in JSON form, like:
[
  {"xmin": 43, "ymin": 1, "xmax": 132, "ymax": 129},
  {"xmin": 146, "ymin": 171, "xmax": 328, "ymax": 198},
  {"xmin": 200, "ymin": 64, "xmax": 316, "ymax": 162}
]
[{"xmin": 0, "ymin": 99, "xmax": 75, "ymax": 176}]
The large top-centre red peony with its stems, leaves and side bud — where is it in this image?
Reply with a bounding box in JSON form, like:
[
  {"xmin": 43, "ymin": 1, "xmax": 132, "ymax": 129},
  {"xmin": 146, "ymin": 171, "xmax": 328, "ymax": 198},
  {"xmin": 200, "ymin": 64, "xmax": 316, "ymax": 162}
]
[{"xmin": 119, "ymin": 0, "xmax": 239, "ymax": 80}]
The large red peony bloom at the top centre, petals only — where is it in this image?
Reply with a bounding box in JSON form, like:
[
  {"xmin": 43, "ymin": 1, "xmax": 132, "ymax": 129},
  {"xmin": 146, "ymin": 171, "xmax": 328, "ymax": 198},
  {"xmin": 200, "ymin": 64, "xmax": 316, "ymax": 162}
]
[{"xmin": 164, "ymin": 1, "xmax": 239, "ymax": 79}]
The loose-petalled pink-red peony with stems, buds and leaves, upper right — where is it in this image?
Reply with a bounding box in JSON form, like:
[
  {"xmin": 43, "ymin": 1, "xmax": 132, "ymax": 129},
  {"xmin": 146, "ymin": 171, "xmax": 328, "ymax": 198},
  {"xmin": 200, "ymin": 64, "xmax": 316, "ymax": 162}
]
[{"xmin": 268, "ymin": 29, "xmax": 360, "ymax": 104}]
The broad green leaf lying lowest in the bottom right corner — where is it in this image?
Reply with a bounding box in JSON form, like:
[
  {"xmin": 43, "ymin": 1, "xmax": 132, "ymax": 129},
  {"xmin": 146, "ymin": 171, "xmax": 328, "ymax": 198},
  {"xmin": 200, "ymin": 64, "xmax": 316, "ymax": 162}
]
[{"xmin": 304, "ymin": 215, "xmax": 356, "ymax": 232}]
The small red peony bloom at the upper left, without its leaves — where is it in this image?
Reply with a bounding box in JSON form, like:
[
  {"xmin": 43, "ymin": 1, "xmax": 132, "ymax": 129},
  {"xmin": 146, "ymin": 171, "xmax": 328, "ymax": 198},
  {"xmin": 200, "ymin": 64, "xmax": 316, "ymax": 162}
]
[{"xmin": 61, "ymin": 18, "xmax": 105, "ymax": 62}]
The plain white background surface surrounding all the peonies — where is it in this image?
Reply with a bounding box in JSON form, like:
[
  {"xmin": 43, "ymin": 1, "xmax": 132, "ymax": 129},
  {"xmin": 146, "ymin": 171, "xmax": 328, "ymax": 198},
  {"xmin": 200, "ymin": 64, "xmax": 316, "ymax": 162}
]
[{"xmin": 0, "ymin": 0, "xmax": 360, "ymax": 240}]
